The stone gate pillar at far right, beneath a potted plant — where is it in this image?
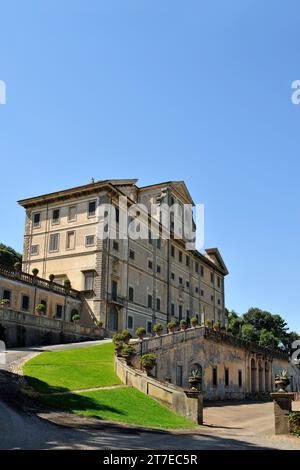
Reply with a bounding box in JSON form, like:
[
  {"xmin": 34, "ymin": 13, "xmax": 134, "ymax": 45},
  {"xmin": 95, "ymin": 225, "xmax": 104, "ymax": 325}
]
[{"xmin": 270, "ymin": 392, "xmax": 294, "ymax": 434}]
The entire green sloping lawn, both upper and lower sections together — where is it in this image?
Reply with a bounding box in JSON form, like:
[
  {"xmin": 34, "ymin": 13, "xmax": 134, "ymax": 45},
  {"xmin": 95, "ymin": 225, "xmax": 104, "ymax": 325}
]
[{"xmin": 23, "ymin": 343, "xmax": 195, "ymax": 429}]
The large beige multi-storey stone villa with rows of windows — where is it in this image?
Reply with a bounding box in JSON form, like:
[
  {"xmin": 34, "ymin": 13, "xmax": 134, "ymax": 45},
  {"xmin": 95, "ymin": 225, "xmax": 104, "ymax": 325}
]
[{"xmin": 19, "ymin": 179, "xmax": 228, "ymax": 333}]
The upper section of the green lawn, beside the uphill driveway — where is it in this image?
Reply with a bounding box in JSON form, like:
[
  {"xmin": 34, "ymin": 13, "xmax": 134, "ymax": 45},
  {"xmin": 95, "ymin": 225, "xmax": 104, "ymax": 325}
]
[{"xmin": 23, "ymin": 343, "xmax": 122, "ymax": 393}]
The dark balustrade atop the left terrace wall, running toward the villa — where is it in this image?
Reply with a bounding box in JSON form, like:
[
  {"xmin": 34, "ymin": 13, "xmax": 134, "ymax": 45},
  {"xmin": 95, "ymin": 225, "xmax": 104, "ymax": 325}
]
[{"xmin": 0, "ymin": 265, "xmax": 80, "ymax": 299}]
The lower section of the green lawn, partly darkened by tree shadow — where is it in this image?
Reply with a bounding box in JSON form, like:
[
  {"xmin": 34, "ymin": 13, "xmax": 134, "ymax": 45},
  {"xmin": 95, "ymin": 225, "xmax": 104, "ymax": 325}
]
[{"xmin": 42, "ymin": 387, "xmax": 196, "ymax": 429}]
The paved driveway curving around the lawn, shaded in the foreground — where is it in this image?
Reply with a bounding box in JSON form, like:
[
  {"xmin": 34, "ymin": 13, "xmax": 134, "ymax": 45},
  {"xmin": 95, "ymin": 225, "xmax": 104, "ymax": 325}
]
[{"xmin": 0, "ymin": 340, "xmax": 300, "ymax": 450}]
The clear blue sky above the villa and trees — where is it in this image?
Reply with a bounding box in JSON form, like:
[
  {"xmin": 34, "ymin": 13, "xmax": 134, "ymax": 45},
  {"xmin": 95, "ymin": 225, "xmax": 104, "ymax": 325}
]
[{"xmin": 0, "ymin": 0, "xmax": 300, "ymax": 331}]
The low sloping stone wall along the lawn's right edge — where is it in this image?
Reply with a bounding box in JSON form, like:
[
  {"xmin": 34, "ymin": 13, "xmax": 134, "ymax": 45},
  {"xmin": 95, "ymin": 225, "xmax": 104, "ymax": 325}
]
[{"xmin": 115, "ymin": 357, "xmax": 203, "ymax": 424}]
